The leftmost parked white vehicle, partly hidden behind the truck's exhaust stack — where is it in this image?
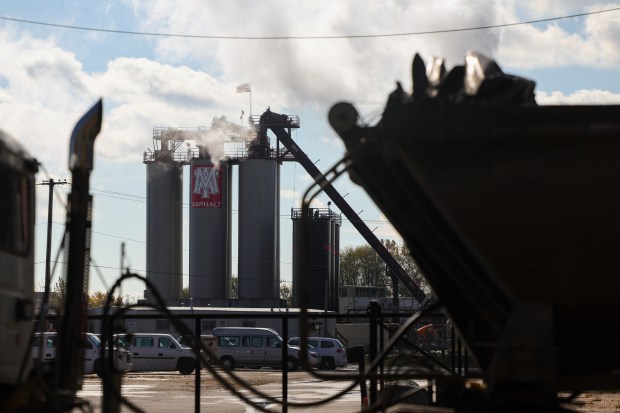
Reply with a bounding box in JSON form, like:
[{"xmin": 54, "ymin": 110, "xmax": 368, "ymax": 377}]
[{"xmin": 31, "ymin": 331, "xmax": 133, "ymax": 377}]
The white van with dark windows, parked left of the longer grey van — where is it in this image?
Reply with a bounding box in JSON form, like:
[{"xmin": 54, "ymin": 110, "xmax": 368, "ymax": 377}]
[{"xmin": 114, "ymin": 333, "xmax": 196, "ymax": 374}]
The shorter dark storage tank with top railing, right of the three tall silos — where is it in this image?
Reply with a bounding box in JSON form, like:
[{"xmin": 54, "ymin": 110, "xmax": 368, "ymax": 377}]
[{"xmin": 291, "ymin": 208, "xmax": 339, "ymax": 310}]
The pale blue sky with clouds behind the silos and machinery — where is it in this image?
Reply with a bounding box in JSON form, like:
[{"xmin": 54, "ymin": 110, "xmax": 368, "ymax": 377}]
[{"xmin": 0, "ymin": 0, "xmax": 620, "ymax": 298}]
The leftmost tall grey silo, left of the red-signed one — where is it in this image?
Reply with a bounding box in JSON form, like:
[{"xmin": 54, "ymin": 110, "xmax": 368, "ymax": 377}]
[{"xmin": 145, "ymin": 140, "xmax": 183, "ymax": 304}]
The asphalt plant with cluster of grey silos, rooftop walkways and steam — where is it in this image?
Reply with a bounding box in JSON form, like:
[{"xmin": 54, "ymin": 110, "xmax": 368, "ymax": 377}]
[{"xmin": 144, "ymin": 111, "xmax": 354, "ymax": 311}]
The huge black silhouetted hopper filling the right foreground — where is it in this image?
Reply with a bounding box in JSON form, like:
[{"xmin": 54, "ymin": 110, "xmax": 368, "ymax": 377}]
[{"xmin": 329, "ymin": 53, "xmax": 620, "ymax": 412}]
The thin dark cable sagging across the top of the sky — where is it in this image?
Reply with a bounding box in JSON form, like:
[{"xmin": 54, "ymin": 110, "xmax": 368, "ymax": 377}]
[{"xmin": 0, "ymin": 7, "xmax": 620, "ymax": 40}]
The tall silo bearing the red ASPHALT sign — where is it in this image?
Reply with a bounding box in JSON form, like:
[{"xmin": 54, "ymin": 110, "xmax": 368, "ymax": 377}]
[{"xmin": 189, "ymin": 151, "xmax": 232, "ymax": 305}]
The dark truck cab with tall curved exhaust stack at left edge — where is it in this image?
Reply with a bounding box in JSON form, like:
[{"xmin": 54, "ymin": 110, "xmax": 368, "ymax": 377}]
[{"xmin": 0, "ymin": 100, "xmax": 101, "ymax": 413}]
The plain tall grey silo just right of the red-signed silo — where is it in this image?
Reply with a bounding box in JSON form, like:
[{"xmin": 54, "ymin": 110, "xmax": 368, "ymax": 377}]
[{"xmin": 238, "ymin": 158, "xmax": 280, "ymax": 299}]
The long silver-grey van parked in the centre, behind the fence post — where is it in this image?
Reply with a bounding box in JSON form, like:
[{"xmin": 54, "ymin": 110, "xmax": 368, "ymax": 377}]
[{"xmin": 213, "ymin": 327, "xmax": 319, "ymax": 371}]
